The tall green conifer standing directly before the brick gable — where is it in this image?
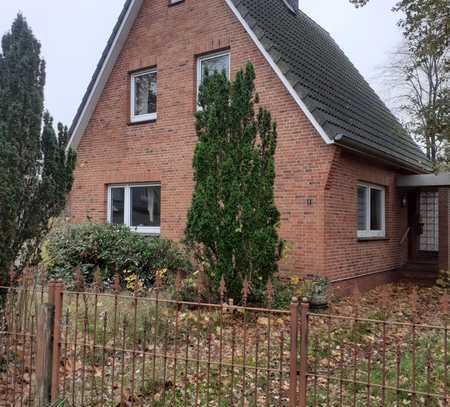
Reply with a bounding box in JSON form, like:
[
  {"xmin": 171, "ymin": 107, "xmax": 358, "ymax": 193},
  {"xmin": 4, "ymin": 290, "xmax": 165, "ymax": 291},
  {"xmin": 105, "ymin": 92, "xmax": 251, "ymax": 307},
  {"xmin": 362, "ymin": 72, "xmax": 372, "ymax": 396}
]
[{"xmin": 186, "ymin": 63, "xmax": 281, "ymax": 301}]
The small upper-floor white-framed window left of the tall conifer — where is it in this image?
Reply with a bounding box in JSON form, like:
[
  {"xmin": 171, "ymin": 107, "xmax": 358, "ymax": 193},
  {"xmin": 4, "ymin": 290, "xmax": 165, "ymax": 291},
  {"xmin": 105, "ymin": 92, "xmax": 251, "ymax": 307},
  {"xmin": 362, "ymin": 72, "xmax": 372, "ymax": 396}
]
[{"xmin": 130, "ymin": 68, "xmax": 158, "ymax": 123}]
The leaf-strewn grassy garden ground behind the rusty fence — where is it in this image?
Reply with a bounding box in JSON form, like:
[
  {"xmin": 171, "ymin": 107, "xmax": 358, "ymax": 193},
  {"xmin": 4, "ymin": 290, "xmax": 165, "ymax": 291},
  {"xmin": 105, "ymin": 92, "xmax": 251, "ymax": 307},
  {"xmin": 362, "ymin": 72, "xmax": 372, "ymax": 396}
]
[{"xmin": 0, "ymin": 284, "xmax": 448, "ymax": 407}]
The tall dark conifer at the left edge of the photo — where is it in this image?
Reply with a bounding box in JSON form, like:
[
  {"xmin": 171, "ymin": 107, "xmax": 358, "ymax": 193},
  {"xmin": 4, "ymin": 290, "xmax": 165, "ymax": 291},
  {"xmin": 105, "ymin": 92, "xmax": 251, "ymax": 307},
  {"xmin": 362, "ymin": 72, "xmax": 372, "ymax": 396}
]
[{"xmin": 0, "ymin": 14, "xmax": 75, "ymax": 284}]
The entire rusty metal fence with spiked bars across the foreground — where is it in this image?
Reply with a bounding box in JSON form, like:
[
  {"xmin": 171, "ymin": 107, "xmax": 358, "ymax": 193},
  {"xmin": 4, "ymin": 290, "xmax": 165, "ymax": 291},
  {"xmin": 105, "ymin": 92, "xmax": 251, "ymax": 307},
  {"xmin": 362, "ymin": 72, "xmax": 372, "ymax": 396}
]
[{"xmin": 0, "ymin": 272, "xmax": 449, "ymax": 407}]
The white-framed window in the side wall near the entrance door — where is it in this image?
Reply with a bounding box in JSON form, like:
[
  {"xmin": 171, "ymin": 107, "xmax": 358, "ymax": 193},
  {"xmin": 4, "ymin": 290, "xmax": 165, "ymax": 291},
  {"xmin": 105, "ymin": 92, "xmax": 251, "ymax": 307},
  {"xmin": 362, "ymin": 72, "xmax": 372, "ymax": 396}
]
[{"xmin": 357, "ymin": 183, "xmax": 386, "ymax": 238}]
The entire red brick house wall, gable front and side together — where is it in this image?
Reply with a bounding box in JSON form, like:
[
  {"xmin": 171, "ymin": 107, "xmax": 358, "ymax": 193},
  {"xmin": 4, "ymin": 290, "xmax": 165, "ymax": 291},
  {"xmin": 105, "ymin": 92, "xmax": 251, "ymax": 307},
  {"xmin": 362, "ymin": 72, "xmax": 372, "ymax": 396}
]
[{"xmin": 70, "ymin": 0, "xmax": 408, "ymax": 277}]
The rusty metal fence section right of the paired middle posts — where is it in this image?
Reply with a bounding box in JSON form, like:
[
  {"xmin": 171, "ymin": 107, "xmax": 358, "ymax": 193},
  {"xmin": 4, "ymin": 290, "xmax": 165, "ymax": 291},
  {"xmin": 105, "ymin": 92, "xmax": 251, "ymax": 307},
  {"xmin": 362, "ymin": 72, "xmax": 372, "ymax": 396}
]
[{"xmin": 307, "ymin": 290, "xmax": 450, "ymax": 407}]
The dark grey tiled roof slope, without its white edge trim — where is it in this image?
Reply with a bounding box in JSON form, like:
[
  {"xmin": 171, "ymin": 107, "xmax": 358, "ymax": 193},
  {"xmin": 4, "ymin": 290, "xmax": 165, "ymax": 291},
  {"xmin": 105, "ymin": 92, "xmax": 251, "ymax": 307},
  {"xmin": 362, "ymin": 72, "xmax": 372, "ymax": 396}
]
[{"xmin": 232, "ymin": 0, "xmax": 430, "ymax": 171}]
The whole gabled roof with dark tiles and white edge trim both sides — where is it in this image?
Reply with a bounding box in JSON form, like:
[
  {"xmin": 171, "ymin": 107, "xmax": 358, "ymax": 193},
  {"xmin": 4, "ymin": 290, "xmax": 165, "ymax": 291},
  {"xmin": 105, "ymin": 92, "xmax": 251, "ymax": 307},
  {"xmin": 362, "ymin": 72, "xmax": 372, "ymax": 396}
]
[{"xmin": 70, "ymin": 0, "xmax": 431, "ymax": 172}]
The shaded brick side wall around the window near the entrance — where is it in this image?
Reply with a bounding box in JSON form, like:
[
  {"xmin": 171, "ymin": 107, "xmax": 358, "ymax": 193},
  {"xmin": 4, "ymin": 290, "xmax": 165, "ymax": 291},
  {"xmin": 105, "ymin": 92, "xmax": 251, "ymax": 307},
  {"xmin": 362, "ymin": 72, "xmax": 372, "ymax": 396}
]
[{"xmin": 325, "ymin": 152, "xmax": 408, "ymax": 279}]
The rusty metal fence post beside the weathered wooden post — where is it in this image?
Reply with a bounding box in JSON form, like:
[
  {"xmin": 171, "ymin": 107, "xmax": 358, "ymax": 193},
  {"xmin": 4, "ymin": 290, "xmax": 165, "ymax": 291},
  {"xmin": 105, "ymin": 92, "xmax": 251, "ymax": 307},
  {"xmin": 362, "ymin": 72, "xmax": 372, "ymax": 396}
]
[{"xmin": 49, "ymin": 281, "xmax": 64, "ymax": 401}]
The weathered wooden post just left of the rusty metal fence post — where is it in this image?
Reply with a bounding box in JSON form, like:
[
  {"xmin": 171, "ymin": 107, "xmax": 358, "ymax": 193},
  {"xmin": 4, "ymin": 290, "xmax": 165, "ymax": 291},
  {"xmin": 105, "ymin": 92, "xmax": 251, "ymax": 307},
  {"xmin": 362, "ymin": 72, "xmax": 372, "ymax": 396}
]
[{"xmin": 34, "ymin": 304, "xmax": 55, "ymax": 407}]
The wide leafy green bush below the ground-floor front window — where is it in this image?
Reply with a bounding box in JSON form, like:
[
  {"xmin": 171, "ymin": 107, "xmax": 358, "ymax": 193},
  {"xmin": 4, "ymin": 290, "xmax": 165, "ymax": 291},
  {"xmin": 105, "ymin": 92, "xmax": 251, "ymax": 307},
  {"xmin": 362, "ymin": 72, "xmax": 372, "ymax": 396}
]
[{"xmin": 42, "ymin": 223, "xmax": 192, "ymax": 286}]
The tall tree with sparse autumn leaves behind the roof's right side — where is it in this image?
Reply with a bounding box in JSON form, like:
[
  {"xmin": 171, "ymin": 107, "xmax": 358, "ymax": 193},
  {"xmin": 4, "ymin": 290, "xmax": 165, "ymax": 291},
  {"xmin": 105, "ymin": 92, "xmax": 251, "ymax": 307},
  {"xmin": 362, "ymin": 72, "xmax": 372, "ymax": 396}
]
[{"xmin": 349, "ymin": 0, "xmax": 450, "ymax": 169}]
